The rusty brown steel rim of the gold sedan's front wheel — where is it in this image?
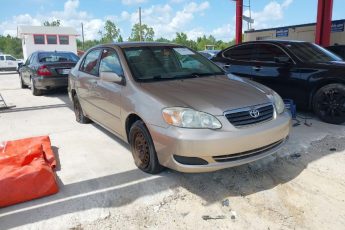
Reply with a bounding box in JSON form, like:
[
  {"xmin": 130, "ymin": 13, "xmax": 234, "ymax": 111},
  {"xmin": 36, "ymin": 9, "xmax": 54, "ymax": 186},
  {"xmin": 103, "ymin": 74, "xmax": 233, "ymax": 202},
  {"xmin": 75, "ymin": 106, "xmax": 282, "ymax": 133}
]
[{"xmin": 133, "ymin": 131, "xmax": 150, "ymax": 168}]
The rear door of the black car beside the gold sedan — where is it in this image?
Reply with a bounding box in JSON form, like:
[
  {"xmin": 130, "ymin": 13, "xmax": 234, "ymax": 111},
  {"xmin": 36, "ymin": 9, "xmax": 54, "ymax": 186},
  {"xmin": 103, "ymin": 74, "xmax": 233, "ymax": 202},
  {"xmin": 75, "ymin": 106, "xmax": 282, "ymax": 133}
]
[{"xmin": 212, "ymin": 44, "xmax": 254, "ymax": 78}]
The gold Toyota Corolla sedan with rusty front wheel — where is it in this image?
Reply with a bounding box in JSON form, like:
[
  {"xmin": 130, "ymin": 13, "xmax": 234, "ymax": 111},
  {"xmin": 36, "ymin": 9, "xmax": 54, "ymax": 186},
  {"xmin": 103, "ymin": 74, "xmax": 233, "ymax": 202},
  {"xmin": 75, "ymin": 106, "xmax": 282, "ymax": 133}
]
[{"xmin": 69, "ymin": 43, "xmax": 291, "ymax": 173}]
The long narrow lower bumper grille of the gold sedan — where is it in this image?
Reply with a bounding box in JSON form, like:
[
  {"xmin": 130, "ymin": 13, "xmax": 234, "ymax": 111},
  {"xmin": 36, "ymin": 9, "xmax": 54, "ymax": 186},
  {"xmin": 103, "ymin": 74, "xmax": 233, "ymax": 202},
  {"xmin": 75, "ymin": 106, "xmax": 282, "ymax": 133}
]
[{"xmin": 213, "ymin": 139, "xmax": 285, "ymax": 163}]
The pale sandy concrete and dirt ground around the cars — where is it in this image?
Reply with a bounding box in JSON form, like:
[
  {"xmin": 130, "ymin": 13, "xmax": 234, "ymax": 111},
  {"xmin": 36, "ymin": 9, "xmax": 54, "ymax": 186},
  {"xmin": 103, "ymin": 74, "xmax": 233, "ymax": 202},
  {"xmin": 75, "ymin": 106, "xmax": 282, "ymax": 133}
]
[{"xmin": 0, "ymin": 73, "xmax": 345, "ymax": 230}]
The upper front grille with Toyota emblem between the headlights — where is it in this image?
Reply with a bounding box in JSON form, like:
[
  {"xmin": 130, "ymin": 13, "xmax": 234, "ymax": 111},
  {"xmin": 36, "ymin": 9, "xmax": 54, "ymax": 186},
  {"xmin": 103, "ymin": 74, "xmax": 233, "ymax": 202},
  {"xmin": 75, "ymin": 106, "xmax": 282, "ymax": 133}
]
[{"xmin": 224, "ymin": 103, "xmax": 274, "ymax": 127}]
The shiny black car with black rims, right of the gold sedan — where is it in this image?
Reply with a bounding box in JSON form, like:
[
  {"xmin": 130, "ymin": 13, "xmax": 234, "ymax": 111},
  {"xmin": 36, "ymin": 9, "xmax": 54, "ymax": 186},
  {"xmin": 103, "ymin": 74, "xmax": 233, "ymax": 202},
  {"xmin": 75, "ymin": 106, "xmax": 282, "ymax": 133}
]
[{"xmin": 212, "ymin": 41, "xmax": 345, "ymax": 124}]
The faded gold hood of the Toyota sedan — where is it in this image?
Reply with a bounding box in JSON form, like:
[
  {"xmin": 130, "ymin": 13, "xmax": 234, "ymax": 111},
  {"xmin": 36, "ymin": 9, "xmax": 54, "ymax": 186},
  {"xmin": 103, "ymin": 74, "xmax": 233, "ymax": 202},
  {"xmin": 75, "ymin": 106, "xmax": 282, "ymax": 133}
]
[{"xmin": 141, "ymin": 76, "xmax": 270, "ymax": 115}]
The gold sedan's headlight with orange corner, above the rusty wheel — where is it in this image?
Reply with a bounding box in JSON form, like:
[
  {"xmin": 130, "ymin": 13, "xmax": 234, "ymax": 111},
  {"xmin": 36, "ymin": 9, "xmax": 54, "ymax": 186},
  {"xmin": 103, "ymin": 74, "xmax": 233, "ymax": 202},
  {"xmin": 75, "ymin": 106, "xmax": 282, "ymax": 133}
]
[{"xmin": 163, "ymin": 107, "xmax": 222, "ymax": 129}]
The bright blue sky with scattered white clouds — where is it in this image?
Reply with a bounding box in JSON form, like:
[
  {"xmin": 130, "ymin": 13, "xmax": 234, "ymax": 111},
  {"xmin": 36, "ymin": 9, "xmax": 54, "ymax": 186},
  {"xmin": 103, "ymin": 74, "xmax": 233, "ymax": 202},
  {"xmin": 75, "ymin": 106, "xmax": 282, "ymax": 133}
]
[{"xmin": 0, "ymin": 0, "xmax": 345, "ymax": 41}]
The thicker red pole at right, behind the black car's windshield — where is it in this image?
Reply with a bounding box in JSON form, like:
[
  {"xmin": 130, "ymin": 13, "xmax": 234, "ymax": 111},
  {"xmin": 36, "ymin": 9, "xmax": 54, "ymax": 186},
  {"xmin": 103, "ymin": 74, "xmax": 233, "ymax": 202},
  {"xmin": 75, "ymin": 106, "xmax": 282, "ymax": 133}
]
[{"xmin": 315, "ymin": 0, "xmax": 333, "ymax": 47}]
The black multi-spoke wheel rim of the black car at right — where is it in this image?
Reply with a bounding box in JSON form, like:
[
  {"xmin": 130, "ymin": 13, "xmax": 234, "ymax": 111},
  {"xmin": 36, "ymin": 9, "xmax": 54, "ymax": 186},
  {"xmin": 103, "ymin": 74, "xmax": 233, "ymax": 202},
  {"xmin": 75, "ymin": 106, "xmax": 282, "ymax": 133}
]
[{"xmin": 318, "ymin": 89, "xmax": 345, "ymax": 117}]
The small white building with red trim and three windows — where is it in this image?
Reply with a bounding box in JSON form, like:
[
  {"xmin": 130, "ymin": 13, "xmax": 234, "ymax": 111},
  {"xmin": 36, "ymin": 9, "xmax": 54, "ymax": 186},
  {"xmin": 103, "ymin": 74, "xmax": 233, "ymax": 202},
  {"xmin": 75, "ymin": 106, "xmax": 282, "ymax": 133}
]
[{"xmin": 17, "ymin": 26, "xmax": 78, "ymax": 60}]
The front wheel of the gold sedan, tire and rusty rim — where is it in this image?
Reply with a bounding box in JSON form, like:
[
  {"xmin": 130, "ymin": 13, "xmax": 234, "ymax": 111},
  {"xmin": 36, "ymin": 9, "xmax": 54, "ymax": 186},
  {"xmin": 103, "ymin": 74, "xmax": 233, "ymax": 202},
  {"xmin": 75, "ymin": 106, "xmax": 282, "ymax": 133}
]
[{"xmin": 129, "ymin": 120, "xmax": 164, "ymax": 174}]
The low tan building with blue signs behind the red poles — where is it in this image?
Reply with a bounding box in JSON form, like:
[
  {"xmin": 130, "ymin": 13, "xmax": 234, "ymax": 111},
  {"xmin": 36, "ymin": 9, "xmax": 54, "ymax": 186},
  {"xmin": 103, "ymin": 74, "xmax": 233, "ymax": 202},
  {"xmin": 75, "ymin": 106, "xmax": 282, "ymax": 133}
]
[{"xmin": 244, "ymin": 19, "xmax": 345, "ymax": 45}]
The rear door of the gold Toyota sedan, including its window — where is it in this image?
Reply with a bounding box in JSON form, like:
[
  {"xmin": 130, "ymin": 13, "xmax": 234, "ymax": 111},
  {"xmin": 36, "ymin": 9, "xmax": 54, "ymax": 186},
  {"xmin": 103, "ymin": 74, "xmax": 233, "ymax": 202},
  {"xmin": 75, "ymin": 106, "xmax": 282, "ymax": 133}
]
[{"xmin": 75, "ymin": 48, "xmax": 102, "ymax": 119}]
